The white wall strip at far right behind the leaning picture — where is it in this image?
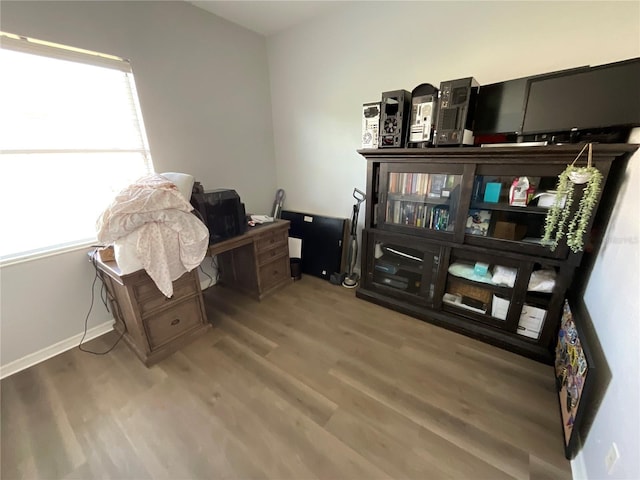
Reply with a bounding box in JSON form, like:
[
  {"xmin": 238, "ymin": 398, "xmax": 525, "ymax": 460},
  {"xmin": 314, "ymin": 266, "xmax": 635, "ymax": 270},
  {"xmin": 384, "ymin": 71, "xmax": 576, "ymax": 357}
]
[{"xmin": 577, "ymin": 129, "xmax": 640, "ymax": 479}]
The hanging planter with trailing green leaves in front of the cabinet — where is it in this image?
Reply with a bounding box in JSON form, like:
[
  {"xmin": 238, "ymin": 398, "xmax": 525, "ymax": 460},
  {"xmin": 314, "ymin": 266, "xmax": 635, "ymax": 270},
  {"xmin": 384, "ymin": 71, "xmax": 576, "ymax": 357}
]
[{"xmin": 542, "ymin": 143, "xmax": 602, "ymax": 253}]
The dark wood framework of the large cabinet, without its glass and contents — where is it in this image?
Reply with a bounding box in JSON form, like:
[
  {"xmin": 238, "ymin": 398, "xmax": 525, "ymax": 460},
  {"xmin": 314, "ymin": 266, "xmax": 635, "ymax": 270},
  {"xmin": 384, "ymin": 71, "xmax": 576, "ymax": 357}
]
[{"xmin": 356, "ymin": 144, "xmax": 638, "ymax": 363}]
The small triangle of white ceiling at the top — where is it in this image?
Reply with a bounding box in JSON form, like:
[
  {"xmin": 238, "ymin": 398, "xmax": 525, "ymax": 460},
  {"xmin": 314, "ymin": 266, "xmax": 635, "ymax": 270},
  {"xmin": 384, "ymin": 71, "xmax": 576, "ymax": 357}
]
[{"xmin": 187, "ymin": 0, "xmax": 342, "ymax": 36}]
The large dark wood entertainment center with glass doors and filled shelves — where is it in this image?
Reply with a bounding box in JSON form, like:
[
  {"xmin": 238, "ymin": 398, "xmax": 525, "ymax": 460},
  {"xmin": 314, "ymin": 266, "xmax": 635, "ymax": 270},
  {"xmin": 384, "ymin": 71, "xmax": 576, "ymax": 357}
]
[{"xmin": 356, "ymin": 144, "xmax": 637, "ymax": 363}]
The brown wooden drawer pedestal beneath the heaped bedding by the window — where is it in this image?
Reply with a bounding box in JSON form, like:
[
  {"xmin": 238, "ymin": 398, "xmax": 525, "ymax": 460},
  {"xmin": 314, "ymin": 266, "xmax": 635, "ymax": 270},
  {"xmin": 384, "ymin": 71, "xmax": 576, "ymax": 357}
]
[{"xmin": 96, "ymin": 259, "xmax": 211, "ymax": 366}]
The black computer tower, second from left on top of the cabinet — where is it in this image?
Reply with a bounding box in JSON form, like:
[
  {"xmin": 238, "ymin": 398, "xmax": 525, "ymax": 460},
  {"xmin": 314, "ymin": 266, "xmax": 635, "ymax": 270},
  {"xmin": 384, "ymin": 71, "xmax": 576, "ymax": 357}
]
[{"xmin": 378, "ymin": 90, "xmax": 411, "ymax": 148}]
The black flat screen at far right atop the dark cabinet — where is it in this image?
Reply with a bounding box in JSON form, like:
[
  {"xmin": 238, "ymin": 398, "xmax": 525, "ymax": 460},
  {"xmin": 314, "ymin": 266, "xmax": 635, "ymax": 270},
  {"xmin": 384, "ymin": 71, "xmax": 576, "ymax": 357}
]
[{"xmin": 522, "ymin": 58, "xmax": 640, "ymax": 135}]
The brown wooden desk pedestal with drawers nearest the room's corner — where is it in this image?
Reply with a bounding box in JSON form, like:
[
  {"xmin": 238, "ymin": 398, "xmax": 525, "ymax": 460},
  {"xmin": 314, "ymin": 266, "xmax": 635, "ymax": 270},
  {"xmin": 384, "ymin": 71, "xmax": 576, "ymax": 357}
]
[{"xmin": 207, "ymin": 220, "xmax": 292, "ymax": 300}]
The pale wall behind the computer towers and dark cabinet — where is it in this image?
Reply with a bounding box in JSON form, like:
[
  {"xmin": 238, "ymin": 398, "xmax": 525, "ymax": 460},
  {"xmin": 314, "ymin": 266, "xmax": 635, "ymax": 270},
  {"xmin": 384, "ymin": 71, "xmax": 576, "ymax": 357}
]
[{"xmin": 267, "ymin": 2, "xmax": 639, "ymax": 217}]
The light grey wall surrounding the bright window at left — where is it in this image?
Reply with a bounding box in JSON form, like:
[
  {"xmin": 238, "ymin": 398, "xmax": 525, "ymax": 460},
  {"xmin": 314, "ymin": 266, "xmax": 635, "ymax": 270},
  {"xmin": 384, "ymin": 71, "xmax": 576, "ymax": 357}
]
[{"xmin": 0, "ymin": 1, "xmax": 276, "ymax": 368}]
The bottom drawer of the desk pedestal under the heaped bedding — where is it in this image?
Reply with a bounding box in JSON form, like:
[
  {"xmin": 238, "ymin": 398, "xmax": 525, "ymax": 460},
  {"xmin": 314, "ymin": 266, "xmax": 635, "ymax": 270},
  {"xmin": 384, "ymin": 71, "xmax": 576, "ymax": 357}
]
[{"xmin": 144, "ymin": 297, "xmax": 202, "ymax": 350}]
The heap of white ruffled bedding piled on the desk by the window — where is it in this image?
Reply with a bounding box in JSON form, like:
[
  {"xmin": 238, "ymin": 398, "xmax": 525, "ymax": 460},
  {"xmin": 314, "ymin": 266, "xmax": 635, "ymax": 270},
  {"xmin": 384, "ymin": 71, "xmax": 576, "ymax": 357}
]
[{"xmin": 96, "ymin": 174, "xmax": 209, "ymax": 297}]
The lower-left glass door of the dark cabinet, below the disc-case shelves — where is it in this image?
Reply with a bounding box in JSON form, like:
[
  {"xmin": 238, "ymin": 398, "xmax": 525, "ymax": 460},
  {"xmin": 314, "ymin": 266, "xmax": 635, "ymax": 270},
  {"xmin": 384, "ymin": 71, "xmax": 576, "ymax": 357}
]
[{"xmin": 365, "ymin": 233, "xmax": 441, "ymax": 306}]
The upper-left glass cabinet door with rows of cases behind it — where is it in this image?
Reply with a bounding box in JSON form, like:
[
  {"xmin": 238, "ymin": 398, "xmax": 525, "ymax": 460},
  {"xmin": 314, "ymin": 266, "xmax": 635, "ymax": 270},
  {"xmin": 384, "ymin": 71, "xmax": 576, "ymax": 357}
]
[{"xmin": 377, "ymin": 164, "xmax": 462, "ymax": 236}]
